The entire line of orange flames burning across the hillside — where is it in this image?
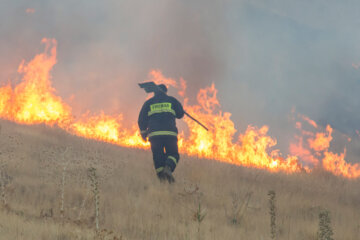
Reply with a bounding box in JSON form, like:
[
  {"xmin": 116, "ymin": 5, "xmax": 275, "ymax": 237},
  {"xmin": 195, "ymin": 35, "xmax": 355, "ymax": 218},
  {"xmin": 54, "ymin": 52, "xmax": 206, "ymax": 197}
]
[{"xmin": 0, "ymin": 39, "xmax": 360, "ymax": 178}]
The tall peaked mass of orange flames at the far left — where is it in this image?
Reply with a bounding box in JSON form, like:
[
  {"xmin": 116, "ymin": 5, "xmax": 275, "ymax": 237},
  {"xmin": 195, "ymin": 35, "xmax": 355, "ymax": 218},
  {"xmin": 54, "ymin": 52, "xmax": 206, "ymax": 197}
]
[{"xmin": 0, "ymin": 39, "xmax": 71, "ymax": 126}]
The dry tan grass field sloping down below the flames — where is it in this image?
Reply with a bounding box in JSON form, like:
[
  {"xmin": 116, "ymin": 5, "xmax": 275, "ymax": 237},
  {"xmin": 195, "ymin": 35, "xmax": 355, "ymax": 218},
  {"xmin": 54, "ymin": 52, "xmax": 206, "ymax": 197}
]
[{"xmin": 0, "ymin": 121, "xmax": 360, "ymax": 240}]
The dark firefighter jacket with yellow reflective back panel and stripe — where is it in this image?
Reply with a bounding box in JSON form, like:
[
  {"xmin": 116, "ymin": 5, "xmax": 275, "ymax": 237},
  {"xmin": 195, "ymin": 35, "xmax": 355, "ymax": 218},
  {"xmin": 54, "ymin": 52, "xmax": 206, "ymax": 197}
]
[{"xmin": 138, "ymin": 93, "xmax": 184, "ymax": 138}]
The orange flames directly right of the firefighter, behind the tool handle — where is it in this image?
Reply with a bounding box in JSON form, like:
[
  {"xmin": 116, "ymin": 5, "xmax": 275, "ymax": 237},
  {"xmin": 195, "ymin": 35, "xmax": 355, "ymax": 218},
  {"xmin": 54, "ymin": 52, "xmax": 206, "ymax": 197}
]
[{"xmin": 180, "ymin": 84, "xmax": 303, "ymax": 173}]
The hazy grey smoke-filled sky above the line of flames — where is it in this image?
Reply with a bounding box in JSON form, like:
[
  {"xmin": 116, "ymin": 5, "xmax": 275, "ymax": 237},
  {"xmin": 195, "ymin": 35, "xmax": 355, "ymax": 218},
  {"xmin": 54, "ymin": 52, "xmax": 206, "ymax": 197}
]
[{"xmin": 0, "ymin": 0, "xmax": 360, "ymax": 154}]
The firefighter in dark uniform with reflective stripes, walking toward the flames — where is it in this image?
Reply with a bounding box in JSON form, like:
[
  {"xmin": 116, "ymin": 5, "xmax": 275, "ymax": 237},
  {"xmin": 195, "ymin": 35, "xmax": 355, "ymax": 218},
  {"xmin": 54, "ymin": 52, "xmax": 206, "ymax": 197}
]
[{"xmin": 138, "ymin": 84, "xmax": 184, "ymax": 183}]
